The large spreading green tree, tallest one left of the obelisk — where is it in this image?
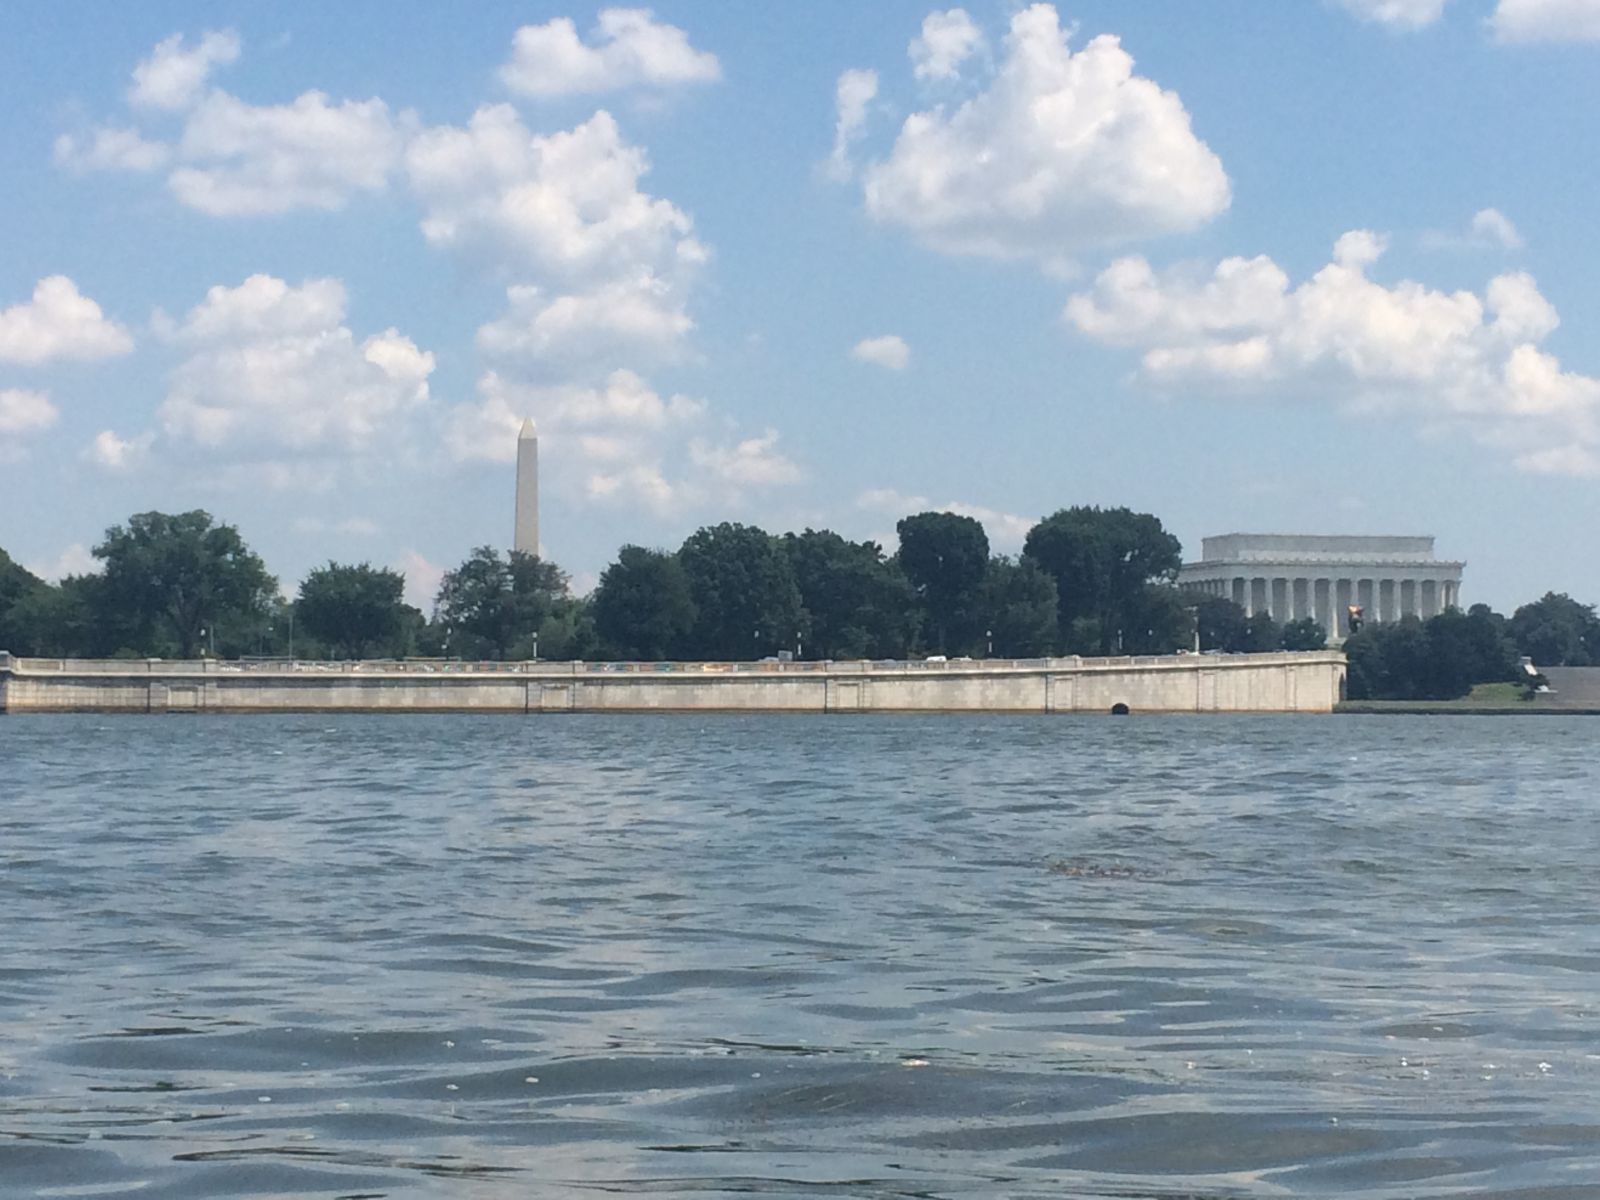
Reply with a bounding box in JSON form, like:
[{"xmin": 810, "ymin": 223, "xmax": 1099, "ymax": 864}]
[{"xmin": 94, "ymin": 509, "xmax": 277, "ymax": 658}]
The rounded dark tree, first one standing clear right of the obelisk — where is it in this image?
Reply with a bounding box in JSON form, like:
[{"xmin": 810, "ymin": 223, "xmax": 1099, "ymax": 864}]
[{"xmin": 590, "ymin": 546, "xmax": 694, "ymax": 661}]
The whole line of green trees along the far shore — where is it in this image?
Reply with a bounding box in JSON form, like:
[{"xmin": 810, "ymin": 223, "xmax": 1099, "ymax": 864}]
[{"xmin": 0, "ymin": 507, "xmax": 1600, "ymax": 699}]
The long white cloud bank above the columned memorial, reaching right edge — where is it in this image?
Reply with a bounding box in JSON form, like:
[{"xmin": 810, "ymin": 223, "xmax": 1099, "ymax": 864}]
[{"xmin": 1066, "ymin": 230, "xmax": 1600, "ymax": 470}]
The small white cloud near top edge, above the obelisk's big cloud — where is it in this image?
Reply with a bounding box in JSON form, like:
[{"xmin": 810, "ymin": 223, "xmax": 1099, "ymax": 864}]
[{"xmin": 501, "ymin": 8, "xmax": 722, "ymax": 99}]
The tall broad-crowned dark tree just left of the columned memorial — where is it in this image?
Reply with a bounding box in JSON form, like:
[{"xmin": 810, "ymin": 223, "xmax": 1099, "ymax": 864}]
[{"xmin": 1022, "ymin": 507, "xmax": 1181, "ymax": 654}]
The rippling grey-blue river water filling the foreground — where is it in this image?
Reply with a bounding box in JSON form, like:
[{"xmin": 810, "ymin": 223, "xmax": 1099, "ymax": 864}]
[{"xmin": 0, "ymin": 717, "xmax": 1600, "ymax": 1200}]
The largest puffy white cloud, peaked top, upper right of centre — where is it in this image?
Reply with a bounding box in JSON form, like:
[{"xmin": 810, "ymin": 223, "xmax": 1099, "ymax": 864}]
[{"xmin": 864, "ymin": 3, "xmax": 1230, "ymax": 262}]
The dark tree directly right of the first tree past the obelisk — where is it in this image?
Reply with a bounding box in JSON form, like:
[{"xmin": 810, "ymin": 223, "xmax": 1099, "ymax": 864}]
[{"xmin": 678, "ymin": 522, "xmax": 805, "ymax": 659}]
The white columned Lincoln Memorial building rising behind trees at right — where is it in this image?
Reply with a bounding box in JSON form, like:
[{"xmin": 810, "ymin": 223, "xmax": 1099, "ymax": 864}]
[{"xmin": 1178, "ymin": 533, "xmax": 1466, "ymax": 638}]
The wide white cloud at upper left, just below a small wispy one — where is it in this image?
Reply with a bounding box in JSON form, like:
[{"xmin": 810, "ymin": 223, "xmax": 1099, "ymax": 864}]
[{"xmin": 166, "ymin": 91, "xmax": 408, "ymax": 216}]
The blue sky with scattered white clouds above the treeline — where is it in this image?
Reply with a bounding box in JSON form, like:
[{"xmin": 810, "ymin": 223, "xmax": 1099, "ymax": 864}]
[{"xmin": 0, "ymin": 0, "xmax": 1600, "ymax": 608}]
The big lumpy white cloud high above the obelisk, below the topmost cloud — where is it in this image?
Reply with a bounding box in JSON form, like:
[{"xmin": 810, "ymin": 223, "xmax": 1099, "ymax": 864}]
[{"xmin": 406, "ymin": 104, "xmax": 709, "ymax": 360}]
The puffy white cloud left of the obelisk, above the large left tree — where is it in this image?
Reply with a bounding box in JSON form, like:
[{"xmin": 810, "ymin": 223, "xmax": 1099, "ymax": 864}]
[{"xmin": 160, "ymin": 275, "xmax": 434, "ymax": 451}]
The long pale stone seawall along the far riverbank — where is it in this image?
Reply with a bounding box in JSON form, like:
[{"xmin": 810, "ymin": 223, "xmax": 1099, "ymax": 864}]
[{"xmin": 0, "ymin": 651, "xmax": 1346, "ymax": 714}]
